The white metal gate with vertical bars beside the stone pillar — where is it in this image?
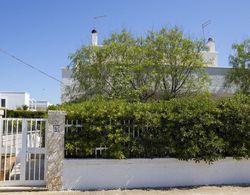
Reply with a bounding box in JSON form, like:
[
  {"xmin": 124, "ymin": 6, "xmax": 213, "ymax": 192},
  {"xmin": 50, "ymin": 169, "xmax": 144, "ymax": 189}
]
[{"xmin": 0, "ymin": 118, "xmax": 47, "ymax": 186}]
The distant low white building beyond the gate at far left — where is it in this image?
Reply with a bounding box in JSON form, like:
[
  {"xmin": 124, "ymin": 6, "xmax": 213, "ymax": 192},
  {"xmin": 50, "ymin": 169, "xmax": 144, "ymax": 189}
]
[{"xmin": 0, "ymin": 92, "xmax": 51, "ymax": 110}]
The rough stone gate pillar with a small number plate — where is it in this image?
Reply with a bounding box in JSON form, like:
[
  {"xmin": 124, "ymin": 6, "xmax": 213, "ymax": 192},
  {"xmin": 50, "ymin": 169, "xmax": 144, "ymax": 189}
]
[{"xmin": 46, "ymin": 111, "xmax": 66, "ymax": 190}]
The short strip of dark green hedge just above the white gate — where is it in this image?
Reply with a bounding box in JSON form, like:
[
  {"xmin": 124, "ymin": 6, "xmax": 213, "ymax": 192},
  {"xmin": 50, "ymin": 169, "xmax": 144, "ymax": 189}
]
[{"xmin": 7, "ymin": 110, "xmax": 48, "ymax": 118}]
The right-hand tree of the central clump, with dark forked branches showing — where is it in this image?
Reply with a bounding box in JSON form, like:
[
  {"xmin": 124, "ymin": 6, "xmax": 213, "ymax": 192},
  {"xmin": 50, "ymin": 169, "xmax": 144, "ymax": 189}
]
[{"xmin": 146, "ymin": 27, "xmax": 208, "ymax": 99}]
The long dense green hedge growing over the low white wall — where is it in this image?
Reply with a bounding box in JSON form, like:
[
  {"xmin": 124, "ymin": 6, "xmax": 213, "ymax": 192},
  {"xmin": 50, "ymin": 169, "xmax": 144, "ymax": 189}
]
[{"xmin": 54, "ymin": 95, "xmax": 250, "ymax": 163}]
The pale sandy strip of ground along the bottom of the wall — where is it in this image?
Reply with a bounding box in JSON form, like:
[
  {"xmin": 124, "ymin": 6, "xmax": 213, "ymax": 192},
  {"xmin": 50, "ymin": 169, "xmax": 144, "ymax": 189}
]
[{"xmin": 0, "ymin": 186, "xmax": 250, "ymax": 195}]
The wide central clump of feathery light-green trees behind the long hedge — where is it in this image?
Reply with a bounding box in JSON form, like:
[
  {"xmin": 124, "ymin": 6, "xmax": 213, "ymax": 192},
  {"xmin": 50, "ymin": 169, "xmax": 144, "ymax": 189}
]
[{"xmin": 68, "ymin": 28, "xmax": 206, "ymax": 101}]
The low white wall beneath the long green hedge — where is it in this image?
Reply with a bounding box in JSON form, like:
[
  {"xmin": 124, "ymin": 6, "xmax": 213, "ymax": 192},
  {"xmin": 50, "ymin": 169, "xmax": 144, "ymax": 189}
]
[{"xmin": 62, "ymin": 158, "xmax": 250, "ymax": 190}]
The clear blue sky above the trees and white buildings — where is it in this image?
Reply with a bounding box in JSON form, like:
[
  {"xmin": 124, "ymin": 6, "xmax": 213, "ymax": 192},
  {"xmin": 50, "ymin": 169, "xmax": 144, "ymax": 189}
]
[{"xmin": 0, "ymin": 0, "xmax": 250, "ymax": 103}]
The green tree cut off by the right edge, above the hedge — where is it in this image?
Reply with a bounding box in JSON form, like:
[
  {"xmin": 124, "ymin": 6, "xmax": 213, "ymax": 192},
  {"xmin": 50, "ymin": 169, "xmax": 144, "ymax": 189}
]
[{"xmin": 225, "ymin": 39, "xmax": 250, "ymax": 94}]
